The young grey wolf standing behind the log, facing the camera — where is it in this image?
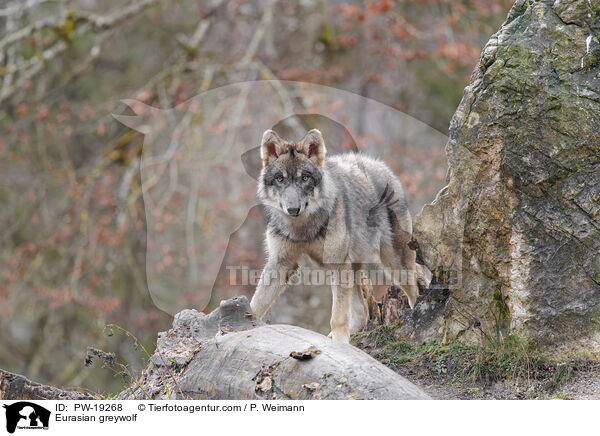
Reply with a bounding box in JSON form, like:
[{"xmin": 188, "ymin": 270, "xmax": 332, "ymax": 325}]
[{"xmin": 250, "ymin": 129, "xmax": 426, "ymax": 343}]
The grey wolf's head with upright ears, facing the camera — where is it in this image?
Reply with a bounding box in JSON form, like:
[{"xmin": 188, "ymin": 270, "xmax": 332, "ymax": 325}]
[{"xmin": 258, "ymin": 129, "xmax": 327, "ymax": 217}]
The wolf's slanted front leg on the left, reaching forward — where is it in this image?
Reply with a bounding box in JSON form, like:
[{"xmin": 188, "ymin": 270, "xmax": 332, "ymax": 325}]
[{"xmin": 250, "ymin": 262, "xmax": 298, "ymax": 318}]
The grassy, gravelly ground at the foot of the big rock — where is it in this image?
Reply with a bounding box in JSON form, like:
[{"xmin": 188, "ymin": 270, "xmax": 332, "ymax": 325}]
[{"xmin": 353, "ymin": 326, "xmax": 600, "ymax": 400}]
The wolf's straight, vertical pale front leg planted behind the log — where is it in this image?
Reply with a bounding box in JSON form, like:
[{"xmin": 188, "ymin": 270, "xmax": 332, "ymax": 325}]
[{"xmin": 329, "ymin": 263, "xmax": 354, "ymax": 343}]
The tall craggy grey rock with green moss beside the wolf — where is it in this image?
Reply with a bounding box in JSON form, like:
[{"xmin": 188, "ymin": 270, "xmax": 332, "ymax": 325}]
[{"xmin": 415, "ymin": 0, "xmax": 600, "ymax": 353}]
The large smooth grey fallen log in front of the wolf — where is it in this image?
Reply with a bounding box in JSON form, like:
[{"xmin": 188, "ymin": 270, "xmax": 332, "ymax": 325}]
[{"xmin": 119, "ymin": 297, "xmax": 429, "ymax": 399}]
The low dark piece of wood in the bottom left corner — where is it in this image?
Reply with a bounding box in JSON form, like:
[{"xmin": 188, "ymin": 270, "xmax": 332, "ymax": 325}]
[{"xmin": 0, "ymin": 369, "xmax": 94, "ymax": 400}]
